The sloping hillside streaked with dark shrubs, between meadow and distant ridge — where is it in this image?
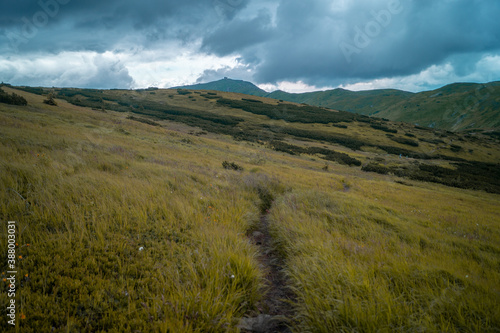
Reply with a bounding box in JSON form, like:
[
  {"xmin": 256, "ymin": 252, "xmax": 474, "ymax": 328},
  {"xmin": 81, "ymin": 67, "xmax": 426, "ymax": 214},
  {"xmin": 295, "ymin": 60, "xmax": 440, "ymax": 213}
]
[{"xmin": 9, "ymin": 83, "xmax": 500, "ymax": 193}]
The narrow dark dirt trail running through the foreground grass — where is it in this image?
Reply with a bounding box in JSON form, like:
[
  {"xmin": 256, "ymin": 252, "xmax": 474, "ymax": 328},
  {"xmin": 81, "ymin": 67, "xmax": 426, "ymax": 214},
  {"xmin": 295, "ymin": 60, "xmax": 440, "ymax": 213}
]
[{"xmin": 240, "ymin": 214, "xmax": 294, "ymax": 333}]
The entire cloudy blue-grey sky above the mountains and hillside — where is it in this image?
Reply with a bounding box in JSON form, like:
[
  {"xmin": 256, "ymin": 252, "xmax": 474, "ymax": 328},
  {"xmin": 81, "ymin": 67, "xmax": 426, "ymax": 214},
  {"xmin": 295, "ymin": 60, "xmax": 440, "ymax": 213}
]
[{"xmin": 0, "ymin": 0, "xmax": 500, "ymax": 92}]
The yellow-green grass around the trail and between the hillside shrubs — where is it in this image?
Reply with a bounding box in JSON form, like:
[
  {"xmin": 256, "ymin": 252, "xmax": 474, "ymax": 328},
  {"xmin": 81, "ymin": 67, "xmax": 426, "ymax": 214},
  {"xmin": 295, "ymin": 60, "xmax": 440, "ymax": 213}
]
[{"xmin": 0, "ymin": 88, "xmax": 500, "ymax": 332}]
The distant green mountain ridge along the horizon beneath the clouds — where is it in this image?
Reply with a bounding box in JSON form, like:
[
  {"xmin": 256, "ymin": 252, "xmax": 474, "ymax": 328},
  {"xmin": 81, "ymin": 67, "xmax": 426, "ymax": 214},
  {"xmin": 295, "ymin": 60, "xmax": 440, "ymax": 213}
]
[{"xmin": 176, "ymin": 78, "xmax": 500, "ymax": 131}]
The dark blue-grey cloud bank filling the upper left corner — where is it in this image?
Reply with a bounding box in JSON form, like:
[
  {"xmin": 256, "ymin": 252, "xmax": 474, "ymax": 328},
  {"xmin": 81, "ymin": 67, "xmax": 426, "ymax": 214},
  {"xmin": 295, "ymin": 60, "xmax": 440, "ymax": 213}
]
[{"xmin": 0, "ymin": 0, "xmax": 247, "ymax": 53}]
